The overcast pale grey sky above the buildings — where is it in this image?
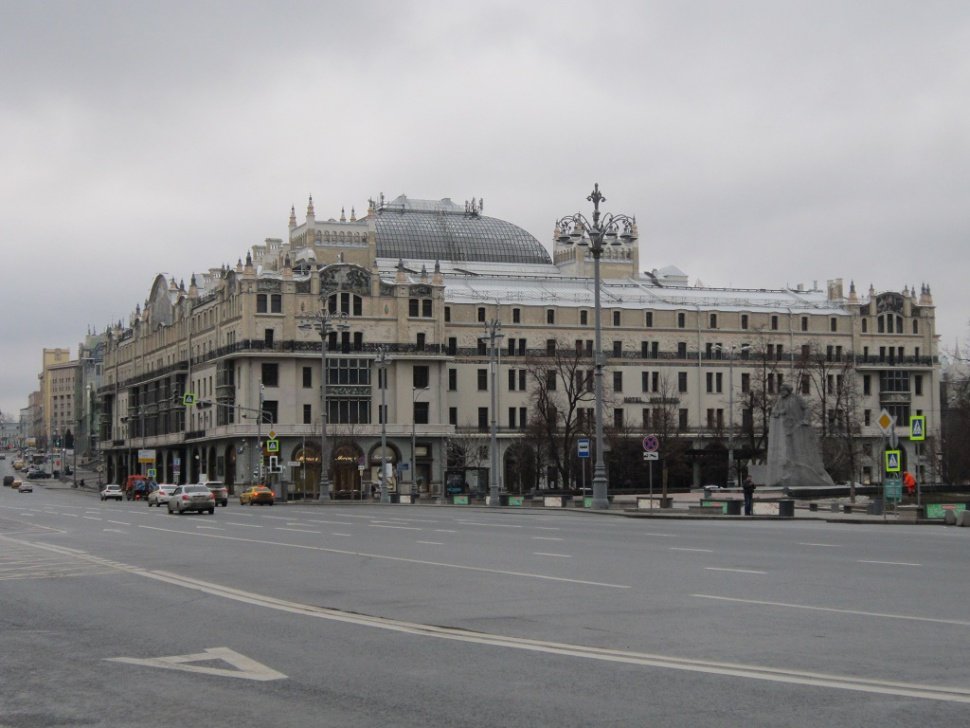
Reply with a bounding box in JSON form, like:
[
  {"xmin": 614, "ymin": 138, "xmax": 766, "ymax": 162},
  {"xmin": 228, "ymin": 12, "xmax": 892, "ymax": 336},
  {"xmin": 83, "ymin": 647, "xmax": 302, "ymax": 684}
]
[{"xmin": 0, "ymin": 0, "xmax": 970, "ymax": 417}]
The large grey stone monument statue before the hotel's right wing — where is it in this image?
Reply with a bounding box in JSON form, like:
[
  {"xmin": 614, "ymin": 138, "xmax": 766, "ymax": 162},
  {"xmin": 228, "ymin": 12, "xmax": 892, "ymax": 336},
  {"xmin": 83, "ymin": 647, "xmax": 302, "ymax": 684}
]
[{"xmin": 765, "ymin": 384, "xmax": 834, "ymax": 487}]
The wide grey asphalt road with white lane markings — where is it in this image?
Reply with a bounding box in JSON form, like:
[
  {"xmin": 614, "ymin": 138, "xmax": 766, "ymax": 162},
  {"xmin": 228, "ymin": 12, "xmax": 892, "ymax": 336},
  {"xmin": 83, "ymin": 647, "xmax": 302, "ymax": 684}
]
[{"xmin": 0, "ymin": 463, "xmax": 970, "ymax": 728}]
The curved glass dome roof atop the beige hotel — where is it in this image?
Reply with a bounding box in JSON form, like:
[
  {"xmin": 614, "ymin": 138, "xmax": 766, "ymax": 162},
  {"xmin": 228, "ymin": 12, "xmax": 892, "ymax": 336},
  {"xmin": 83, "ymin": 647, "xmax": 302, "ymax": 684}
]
[{"xmin": 374, "ymin": 195, "xmax": 551, "ymax": 264}]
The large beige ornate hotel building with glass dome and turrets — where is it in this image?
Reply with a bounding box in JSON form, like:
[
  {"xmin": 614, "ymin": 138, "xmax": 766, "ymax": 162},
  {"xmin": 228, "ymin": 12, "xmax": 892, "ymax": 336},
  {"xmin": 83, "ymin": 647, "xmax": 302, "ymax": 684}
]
[{"xmin": 97, "ymin": 196, "xmax": 939, "ymax": 497}]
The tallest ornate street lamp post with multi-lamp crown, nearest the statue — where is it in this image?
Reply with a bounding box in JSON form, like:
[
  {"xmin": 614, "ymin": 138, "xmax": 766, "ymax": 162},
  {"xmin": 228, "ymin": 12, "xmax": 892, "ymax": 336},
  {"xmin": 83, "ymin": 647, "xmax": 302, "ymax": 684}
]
[{"xmin": 556, "ymin": 182, "xmax": 637, "ymax": 509}]
